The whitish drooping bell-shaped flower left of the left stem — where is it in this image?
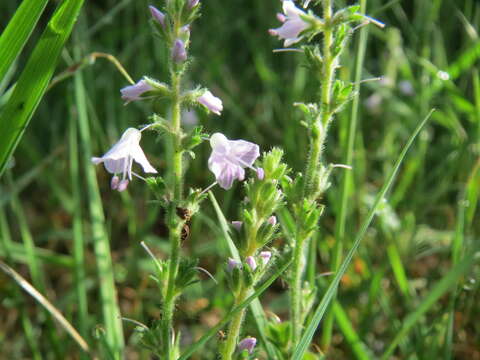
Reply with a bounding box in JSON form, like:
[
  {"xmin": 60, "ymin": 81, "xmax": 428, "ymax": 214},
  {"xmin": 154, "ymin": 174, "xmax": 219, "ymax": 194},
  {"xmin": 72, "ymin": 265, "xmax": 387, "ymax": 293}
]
[{"xmin": 92, "ymin": 128, "xmax": 157, "ymax": 191}]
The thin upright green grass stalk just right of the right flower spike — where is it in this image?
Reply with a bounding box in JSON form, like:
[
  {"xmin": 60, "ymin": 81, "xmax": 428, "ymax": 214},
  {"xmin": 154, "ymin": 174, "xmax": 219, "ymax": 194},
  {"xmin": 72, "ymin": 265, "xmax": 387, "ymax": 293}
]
[{"xmin": 321, "ymin": 0, "xmax": 368, "ymax": 350}]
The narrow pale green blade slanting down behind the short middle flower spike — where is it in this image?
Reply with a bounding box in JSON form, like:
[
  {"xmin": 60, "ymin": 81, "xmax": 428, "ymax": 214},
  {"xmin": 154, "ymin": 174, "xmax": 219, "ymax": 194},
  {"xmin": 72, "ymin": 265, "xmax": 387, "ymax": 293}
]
[{"xmin": 208, "ymin": 191, "xmax": 277, "ymax": 360}]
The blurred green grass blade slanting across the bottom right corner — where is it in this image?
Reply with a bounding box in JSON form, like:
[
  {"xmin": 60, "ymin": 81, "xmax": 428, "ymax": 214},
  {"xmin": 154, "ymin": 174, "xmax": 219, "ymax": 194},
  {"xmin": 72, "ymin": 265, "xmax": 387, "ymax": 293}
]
[{"xmin": 381, "ymin": 253, "xmax": 476, "ymax": 360}]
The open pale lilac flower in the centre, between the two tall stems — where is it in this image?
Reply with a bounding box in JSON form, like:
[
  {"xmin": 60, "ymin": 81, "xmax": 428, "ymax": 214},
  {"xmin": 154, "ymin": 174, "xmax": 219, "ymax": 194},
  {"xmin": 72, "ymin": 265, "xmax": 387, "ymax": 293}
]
[{"xmin": 208, "ymin": 133, "xmax": 260, "ymax": 190}]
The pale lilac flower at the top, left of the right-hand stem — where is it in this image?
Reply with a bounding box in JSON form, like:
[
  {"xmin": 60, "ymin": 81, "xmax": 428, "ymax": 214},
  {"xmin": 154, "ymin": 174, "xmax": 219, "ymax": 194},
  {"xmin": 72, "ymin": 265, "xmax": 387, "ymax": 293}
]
[{"xmin": 269, "ymin": 0, "xmax": 309, "ymax": 47}]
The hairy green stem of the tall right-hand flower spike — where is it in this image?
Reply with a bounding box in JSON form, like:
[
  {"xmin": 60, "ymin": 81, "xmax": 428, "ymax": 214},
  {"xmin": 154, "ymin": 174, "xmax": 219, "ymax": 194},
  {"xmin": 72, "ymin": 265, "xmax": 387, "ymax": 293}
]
[{"xmin": 290, "ymin": 0, "xmax": 337, "ymax": 347}]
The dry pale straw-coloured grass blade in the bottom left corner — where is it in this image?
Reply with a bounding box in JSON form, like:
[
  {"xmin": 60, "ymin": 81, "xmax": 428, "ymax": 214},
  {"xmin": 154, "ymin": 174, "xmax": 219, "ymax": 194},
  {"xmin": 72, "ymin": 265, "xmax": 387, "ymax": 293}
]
[{"xmin": 0, "ymin": 261, "xmax": 90, "ymax": 352}]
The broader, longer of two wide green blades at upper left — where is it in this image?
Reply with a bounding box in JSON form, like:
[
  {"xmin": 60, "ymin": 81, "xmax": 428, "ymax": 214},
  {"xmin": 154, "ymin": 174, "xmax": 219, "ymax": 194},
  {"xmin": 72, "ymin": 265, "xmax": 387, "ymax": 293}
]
[{"xmin": 0, "ymin": 0, "xmax": 83, "ymax": 176}]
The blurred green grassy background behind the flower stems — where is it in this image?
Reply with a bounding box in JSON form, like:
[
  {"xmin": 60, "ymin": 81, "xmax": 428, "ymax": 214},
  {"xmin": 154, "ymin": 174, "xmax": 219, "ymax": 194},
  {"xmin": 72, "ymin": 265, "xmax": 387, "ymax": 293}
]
[{"xmin": 0, "ymin": 0, "xmax": 480, "ymax": 360}]
